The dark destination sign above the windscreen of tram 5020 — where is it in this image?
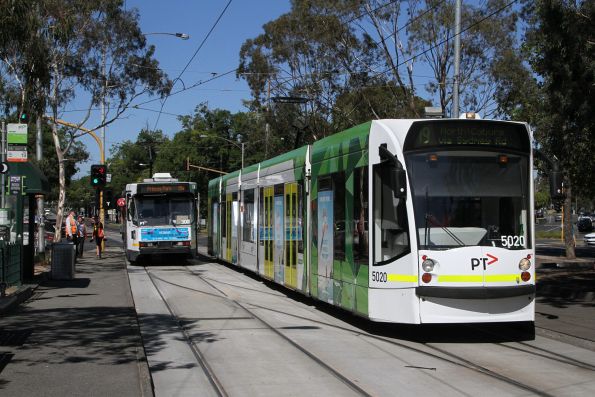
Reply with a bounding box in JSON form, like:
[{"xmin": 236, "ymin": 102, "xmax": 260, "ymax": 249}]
[{"xmin": 403, "ymin": 120, "xmax": 529, "ymax": 151}]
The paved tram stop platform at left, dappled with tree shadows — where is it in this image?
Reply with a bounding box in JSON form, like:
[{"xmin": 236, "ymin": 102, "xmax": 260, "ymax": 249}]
[{"xmin": 0, "ymin": 229, "xmax": 153, "ymax": 396}]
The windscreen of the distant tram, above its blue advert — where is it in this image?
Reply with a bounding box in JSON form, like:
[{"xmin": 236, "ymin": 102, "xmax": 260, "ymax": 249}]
[{"xmin": 135, "ymin": 195, "xmax": 194, "ymax": 226}]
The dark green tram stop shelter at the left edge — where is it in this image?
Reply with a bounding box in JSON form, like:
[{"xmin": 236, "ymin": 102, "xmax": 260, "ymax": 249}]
[{"xmin": 0, "ymin": 162, "xmax": 50, "ymax": 294}]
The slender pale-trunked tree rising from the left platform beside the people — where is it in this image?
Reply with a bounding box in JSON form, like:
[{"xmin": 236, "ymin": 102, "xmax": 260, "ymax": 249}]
[{"xmin": 40, "ymin": 0, "xmax": 171, "ymax": 241}]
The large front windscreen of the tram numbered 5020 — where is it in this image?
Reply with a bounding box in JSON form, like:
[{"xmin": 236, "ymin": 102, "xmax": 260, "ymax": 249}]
[{"xmin": 406, "ymin": 151, "xmax": 531, "ymax": 249}]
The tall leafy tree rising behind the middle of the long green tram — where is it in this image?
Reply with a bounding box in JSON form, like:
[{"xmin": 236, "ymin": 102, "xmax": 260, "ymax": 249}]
[{"xmin": 238, "ymin": 0, "xmax": 378, "ymax": 142}]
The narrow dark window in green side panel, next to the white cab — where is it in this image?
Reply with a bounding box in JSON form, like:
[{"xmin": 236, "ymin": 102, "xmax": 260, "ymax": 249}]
[{"xmin": 353, "ymin": 166, "xmax": 369, "ymax": 264}]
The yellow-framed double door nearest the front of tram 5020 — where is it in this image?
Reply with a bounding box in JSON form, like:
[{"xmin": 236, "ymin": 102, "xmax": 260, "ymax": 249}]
[{"xmin": 284, "ymin": 182, "xmax": 299, "ymax": 288}]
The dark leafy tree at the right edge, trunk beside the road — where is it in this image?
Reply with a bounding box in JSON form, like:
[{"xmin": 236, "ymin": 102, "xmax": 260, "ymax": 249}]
[{"xmin": 525, "ymin": 0, "xmax": 595, "ymax": 258}]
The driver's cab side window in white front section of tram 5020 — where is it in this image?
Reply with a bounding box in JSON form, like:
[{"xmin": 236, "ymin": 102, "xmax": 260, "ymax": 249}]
[{"xmin": 374, "ymin": 162, "xmax": 411, "ymax": 265}]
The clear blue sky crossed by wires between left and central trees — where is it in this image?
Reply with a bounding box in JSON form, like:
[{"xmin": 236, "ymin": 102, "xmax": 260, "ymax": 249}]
[{"xmin": 73, "ymin": 0, "xmax": 290, "ymax": 167}]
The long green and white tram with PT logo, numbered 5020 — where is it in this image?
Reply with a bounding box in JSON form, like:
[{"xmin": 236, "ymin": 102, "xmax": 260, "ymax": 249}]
[{"xmin": 208, "ymin": 113, "xmax": 535, "ymax": 324}]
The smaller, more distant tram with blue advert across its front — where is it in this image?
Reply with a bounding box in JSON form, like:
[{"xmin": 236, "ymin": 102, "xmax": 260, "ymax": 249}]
[{"xmin": 122, "ymin": 173, "xmax": 199, "ymax": 262}]
